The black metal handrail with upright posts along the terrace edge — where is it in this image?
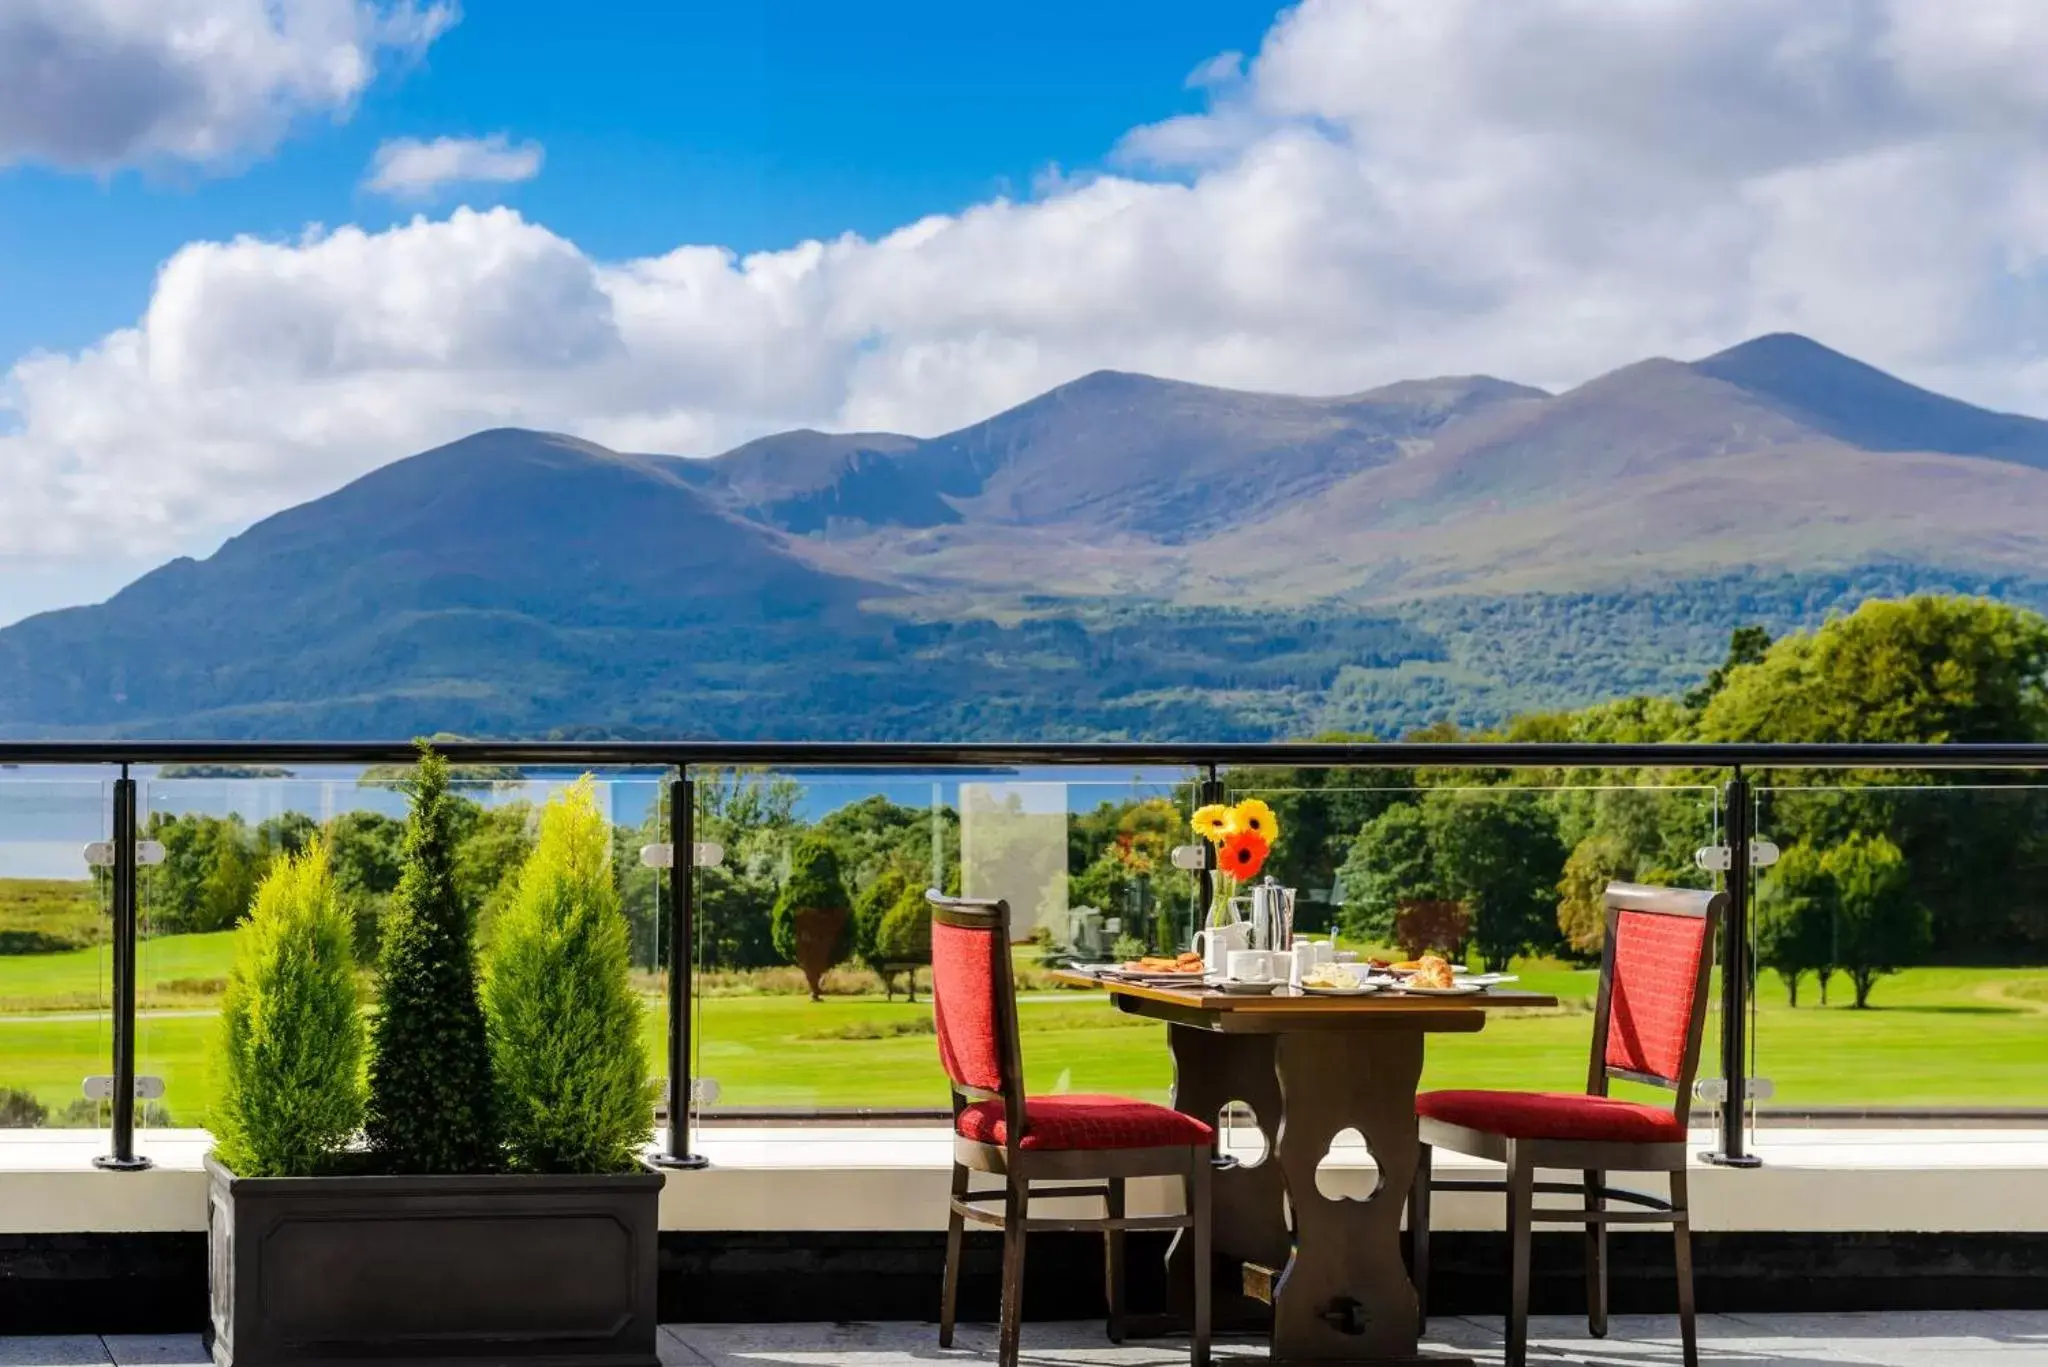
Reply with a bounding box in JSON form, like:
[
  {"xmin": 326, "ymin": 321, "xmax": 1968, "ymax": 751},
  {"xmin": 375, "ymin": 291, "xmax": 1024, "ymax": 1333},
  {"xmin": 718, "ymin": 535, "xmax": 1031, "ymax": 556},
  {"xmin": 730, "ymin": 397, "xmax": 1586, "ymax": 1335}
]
[{"xmin": 0, "ymin": 740, "xmax": 2048, "ymax": 1170}]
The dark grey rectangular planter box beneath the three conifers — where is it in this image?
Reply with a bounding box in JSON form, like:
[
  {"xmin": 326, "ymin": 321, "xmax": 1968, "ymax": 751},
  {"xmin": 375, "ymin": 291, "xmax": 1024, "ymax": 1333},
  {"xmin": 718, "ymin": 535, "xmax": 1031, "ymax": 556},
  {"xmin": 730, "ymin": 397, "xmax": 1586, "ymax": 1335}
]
[{"xmin": 207, "ymin": 1158, "xmax": 662, "ymax": 1367}]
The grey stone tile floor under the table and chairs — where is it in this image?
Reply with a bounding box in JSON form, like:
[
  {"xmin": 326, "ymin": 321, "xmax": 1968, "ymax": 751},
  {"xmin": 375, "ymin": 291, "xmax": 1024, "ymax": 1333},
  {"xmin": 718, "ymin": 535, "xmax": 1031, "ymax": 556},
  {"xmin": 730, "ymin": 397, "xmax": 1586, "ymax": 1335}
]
[{"xmin": 0, "ymin": 1310, "xmax": 2048, "ymax": 1367}]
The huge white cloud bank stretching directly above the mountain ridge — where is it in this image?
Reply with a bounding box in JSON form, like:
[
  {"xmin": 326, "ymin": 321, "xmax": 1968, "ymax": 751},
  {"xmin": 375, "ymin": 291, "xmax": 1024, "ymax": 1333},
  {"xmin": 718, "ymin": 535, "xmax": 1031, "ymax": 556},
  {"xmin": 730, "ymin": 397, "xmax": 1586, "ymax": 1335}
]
[{"xmin": 0, "ymin": 0, "xmax": 2048, "ymax": 610}]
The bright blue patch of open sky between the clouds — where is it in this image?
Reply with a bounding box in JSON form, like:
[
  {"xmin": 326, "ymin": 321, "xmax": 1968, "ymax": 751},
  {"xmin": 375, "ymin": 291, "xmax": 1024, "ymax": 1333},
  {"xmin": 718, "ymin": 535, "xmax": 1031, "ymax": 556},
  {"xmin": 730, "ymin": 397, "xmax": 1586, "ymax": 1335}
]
[{"xmin": 0, "ymin": 0, "xmax": 1280, "ymax": 368}]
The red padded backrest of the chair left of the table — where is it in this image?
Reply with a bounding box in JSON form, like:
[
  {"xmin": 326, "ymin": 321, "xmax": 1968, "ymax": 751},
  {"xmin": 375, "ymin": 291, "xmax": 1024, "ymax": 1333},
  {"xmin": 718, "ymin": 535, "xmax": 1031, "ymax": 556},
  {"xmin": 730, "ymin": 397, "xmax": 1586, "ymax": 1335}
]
[{"xmin": 924, "ymin": 892, "xmax": 1024, "ymax": 1115}]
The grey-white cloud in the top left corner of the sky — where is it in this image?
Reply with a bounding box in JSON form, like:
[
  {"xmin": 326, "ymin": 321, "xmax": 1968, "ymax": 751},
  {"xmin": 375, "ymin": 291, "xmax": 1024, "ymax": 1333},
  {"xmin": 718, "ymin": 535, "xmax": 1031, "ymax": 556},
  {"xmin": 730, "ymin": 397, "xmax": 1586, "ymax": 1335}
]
[{"xmin": 0, "ymin": 0, "xmax": 455, "ymax": 172}]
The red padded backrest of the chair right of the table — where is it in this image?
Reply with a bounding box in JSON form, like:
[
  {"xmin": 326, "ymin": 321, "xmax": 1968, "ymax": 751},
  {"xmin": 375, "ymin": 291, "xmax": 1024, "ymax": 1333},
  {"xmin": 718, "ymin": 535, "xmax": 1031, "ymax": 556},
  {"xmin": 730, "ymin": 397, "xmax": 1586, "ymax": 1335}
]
[{"xmin": 1587, "ymin": 883, "xmax": 1729, "ymax": 1119}]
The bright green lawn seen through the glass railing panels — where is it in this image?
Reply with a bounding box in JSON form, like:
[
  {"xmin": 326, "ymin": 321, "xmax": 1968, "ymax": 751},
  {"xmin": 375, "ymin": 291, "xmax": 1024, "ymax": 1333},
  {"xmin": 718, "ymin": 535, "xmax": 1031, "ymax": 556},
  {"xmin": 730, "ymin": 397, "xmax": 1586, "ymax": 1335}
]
[{"xmin": 0, "ymin": 935, "xmax": 2048, "ymax": 1121}]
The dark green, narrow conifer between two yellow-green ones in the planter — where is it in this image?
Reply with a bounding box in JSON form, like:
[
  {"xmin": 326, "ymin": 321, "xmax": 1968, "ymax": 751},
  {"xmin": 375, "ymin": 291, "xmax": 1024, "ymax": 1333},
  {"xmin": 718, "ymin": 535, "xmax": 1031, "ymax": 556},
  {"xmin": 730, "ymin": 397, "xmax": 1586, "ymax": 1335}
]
[{"xmin": 365, "ymin": 742, "xmax": 500, "ymax": 1172}]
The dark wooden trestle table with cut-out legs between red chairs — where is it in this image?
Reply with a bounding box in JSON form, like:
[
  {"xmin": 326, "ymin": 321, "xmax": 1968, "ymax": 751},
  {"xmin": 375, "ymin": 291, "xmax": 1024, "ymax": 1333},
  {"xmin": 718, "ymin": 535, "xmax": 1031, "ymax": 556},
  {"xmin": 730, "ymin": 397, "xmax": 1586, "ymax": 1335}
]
[{"xmin": 1061, "ymin": 974, "xmax": 1556, "ymax": 1367}]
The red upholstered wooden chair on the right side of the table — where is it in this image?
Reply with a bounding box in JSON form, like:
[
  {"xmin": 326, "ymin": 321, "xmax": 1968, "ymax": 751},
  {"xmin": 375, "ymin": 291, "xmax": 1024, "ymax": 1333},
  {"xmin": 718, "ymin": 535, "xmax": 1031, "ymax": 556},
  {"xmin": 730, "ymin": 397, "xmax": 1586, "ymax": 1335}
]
[{"xmin": 1409, "ymin": 883, "xmax": 1726, "ymax": 1367}]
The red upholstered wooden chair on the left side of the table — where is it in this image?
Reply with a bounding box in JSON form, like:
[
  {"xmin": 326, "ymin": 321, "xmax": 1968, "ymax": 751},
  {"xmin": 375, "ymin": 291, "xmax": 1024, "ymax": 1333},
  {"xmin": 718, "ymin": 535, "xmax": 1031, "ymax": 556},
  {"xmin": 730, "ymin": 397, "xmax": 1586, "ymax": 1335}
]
[{"xmin": 926, "ymin": 892, "xmax": 1217, "ymax": 1367}]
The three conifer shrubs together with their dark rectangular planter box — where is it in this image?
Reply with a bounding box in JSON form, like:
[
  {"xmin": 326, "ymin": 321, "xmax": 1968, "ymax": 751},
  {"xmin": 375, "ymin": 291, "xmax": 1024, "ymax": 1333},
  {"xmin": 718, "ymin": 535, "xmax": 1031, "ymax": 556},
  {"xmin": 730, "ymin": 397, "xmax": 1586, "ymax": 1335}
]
[{"xmin": 207, "ymin": 746, "xmax": 662, "ymax": 1367}]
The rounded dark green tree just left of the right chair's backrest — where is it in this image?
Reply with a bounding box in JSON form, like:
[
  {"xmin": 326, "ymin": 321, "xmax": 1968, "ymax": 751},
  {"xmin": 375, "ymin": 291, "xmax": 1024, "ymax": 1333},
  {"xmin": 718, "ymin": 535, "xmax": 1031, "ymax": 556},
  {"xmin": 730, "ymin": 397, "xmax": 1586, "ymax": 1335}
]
[{"xmin": 1425, "ymin": 791, "xmax": 1565, "ymax": 969}]
